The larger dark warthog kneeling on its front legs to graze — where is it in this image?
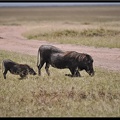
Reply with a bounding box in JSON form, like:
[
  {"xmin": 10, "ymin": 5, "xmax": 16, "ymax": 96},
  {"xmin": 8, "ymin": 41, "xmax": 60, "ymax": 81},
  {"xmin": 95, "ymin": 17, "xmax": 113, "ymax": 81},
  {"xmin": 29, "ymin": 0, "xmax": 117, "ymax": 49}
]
[{"xmin": 37, "ymin": 45, "xmax": 94, "ymax": 77}]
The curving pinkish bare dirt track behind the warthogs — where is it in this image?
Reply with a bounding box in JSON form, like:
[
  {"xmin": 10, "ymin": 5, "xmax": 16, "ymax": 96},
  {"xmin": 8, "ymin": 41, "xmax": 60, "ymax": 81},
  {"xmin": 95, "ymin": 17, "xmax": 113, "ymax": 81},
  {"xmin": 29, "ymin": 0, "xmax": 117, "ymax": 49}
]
[{"xmin": 0, "ymin": 26, "xmax": 120, "ymax": 71}]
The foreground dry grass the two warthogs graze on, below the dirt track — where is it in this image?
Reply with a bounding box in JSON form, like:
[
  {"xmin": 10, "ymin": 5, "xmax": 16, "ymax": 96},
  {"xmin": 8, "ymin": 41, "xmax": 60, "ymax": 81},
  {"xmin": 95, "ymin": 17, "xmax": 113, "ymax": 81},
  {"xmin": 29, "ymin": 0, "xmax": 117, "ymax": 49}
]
[{"xmin": 0, "ymin": 51, "xmax": 120, "ymax": 117}]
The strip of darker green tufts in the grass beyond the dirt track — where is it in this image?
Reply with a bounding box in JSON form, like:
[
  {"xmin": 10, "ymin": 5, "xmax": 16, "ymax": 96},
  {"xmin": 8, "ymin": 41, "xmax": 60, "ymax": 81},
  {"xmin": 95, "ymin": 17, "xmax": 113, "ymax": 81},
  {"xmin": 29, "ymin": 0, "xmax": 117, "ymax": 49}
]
[{"xmin": 28, "ymin": 28, "xmax": 120, "ymax": 39}]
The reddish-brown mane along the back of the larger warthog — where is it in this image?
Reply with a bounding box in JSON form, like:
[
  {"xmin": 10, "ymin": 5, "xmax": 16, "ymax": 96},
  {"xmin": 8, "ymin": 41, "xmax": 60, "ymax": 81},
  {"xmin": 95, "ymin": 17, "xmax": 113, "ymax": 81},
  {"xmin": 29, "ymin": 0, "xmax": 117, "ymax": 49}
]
[{"xmin": 64, "ymin": 51, "xmax": 87, "ymax": 61}]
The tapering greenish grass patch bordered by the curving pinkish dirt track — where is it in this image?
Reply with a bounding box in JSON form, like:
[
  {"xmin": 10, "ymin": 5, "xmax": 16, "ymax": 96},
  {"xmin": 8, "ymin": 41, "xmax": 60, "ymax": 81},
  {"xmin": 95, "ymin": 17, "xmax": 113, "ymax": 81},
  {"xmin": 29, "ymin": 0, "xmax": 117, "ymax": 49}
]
[{"xmin": 23, "ymin": 28, "xmax": 120, "ymax": 48}]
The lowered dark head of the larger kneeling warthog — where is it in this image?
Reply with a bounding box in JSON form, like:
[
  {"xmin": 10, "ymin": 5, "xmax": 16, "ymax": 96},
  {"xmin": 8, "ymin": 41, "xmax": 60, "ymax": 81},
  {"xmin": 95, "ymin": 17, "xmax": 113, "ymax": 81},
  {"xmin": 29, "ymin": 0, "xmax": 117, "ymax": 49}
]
[{"xmin": 83, "ymin": 54, "xmax": 95, "ymax": 76}]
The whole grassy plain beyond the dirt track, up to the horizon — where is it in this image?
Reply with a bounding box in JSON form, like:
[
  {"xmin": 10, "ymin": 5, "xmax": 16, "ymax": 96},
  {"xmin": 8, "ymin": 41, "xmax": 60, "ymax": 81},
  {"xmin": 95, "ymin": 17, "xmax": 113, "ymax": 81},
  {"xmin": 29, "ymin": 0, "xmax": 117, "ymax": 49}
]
[{"xmin": 0, "ymin": 6, "xmax": 120, "ymax": 48}]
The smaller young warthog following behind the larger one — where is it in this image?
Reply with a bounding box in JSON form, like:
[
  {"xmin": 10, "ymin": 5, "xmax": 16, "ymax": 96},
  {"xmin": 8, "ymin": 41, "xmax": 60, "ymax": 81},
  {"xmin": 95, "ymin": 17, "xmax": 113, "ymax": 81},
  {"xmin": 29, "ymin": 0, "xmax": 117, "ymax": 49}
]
[{"xmin": 2, "ymin": 59, "xmax": 36, "ymax": 79}]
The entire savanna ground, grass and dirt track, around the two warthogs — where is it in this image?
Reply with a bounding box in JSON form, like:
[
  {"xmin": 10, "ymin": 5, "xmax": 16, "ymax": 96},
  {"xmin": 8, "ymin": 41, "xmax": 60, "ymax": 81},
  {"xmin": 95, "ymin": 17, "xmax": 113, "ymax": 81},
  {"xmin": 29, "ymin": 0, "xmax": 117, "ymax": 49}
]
[{"xmin": 0, "ymin": 6, "xmax": 120, "ymax": 117}]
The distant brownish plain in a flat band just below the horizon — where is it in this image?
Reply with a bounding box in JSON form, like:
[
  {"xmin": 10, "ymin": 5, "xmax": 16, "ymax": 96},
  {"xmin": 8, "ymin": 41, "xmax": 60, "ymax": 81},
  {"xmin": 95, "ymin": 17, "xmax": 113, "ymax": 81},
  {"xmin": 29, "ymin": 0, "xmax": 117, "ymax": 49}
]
[{"xmin": 0, "ymin": 6, "xmax": 120, "ymax": 24}]
